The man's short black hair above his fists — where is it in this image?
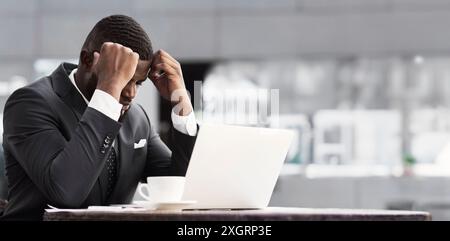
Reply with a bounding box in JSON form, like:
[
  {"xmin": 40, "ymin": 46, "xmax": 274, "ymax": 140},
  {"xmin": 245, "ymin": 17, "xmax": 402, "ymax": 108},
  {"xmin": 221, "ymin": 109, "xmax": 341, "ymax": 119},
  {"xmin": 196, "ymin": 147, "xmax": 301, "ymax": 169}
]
[{"xmin": 83, "ymin": 15, "xmax": 153, "ymax": 60}]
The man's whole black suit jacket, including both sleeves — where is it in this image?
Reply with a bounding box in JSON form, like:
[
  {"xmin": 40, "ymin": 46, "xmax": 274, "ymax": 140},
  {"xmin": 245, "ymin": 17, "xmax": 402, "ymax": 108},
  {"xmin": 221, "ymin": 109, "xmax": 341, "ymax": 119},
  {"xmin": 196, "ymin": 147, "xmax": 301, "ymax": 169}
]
[{"xmin": 1, "ymin": 63, "xmax": 195, "ymax": 220}]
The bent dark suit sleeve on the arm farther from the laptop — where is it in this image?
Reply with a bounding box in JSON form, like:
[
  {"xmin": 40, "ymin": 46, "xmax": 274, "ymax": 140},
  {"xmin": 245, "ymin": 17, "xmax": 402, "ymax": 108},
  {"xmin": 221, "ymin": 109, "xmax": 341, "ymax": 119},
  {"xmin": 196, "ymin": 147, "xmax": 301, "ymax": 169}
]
[{"xmin": 3, "ymin": 87, "xmax": 121, "ymax": 207}]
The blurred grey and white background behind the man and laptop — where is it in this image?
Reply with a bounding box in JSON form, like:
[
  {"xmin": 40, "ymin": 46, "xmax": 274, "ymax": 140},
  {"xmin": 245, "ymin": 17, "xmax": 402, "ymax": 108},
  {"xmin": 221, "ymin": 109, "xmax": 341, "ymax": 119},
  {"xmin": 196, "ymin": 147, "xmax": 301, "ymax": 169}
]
[{"xmin": 4, "ymin": 0, "xmax": 450, "ymax": 220}]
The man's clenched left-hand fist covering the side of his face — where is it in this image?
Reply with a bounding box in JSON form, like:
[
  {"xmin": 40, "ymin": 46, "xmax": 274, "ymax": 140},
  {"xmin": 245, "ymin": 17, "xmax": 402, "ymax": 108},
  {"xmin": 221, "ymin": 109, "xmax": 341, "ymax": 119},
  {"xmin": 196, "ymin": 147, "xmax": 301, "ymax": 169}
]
[{"xmin": 93, "ymin": 42, "xmax": 139, "ymax": 101}]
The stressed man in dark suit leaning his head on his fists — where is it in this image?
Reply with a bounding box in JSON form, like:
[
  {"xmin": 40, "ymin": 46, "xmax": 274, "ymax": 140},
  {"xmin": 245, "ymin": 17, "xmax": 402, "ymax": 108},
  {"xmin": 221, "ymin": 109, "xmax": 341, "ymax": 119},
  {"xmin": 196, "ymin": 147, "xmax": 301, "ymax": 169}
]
[{"xmin": 2, "ymin": 15, "xmax": 198, "ymax": 220}]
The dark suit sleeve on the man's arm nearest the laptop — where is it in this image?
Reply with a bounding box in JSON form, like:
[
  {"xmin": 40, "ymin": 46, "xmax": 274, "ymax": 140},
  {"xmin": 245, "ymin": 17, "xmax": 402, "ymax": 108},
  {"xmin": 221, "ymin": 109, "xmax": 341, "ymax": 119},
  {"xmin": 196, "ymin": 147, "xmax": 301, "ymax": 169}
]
[{"xmin": 142, "ymin": 104, "xmax": 197, "ymax": 179}]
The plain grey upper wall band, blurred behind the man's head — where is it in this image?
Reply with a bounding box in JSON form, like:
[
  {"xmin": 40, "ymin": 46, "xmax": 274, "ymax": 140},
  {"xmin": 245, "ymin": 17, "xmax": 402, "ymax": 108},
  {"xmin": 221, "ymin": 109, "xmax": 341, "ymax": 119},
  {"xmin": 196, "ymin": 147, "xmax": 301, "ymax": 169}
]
[{"xmin": 0, "ymin": 0, "xmax": 450, "ymax": 107}]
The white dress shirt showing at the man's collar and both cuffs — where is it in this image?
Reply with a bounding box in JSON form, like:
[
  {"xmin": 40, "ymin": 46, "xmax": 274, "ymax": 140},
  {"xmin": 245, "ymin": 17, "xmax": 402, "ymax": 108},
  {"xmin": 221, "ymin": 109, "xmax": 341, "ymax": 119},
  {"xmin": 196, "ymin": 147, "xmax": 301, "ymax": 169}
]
[{"xmin": 69, "ymin": 69, "xmax": 197, "ymax": 136}]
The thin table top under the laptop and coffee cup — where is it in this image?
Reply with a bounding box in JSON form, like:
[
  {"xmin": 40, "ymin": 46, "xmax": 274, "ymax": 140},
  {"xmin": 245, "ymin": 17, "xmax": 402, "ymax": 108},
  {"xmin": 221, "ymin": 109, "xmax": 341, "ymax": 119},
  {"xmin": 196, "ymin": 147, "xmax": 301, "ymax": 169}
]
[{"xmin": 44, "ymin": 207, "xmax": 431, "ymax": 221}]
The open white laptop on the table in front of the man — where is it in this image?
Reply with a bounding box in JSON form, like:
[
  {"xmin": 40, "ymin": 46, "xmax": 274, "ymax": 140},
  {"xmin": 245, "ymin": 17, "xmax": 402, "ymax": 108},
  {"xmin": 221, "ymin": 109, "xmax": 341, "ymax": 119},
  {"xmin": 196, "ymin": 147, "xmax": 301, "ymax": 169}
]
[{"xmin": 182, "ymin": 124, "xmax": 293, "ymax": 209}]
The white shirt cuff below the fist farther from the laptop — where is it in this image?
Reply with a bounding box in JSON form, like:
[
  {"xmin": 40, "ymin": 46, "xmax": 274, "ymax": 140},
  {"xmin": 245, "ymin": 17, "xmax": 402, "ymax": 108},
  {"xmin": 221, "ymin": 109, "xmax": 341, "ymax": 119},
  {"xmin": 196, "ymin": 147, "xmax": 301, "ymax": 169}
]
[{"xmin": 88, "ymin": 89, "xmax": 122, "ymax": 121}]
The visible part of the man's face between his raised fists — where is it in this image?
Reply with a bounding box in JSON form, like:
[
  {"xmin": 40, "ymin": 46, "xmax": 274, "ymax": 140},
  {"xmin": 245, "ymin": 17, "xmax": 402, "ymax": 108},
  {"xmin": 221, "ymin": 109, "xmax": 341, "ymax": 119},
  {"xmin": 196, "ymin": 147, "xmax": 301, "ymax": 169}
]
[{"xmin": 119, "ymin": 60, "xmax": 151, "ymax": 111}]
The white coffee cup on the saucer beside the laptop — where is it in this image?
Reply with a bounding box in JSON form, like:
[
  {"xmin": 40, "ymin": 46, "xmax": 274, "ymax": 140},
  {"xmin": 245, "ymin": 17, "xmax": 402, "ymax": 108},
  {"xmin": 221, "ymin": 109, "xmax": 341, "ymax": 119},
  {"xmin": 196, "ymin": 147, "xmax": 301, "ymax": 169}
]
[{"xmin": 138, "ymin": 176, "xmax": 185, "ymax": 202}]
